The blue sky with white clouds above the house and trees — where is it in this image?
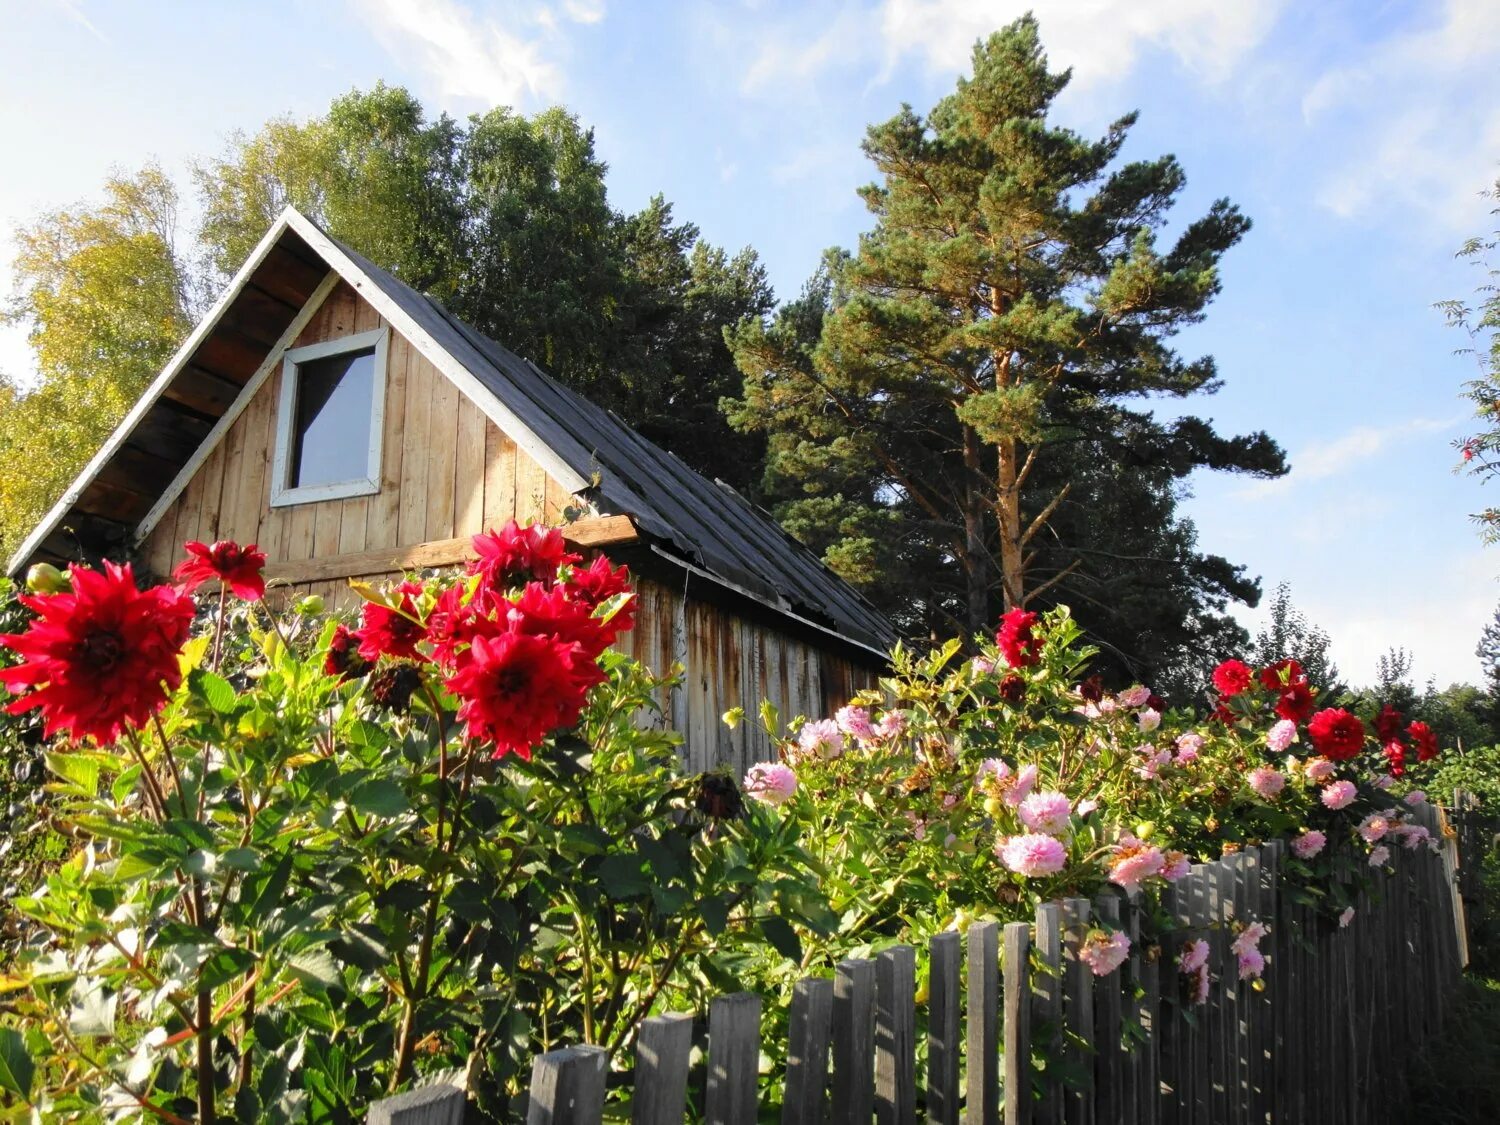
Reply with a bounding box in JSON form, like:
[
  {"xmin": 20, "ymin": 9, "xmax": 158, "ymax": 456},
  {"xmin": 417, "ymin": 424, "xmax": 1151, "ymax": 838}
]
[{"xmin": 0, "ymin": 0, "xmax": 1500, "ymax": 684}]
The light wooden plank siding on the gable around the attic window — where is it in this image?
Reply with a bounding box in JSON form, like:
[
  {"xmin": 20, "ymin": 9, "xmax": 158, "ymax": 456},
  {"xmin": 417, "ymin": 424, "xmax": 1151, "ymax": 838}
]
[{"xmin": 143, "ymin": 284, "xmax": 572, "ymax": 575}]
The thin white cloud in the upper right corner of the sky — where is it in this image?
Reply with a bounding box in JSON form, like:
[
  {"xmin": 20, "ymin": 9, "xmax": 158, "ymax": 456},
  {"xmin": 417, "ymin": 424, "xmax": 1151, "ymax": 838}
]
[{"xmin": 1302, "ymin": 0, "xmax": 1500, "ymax": 234}]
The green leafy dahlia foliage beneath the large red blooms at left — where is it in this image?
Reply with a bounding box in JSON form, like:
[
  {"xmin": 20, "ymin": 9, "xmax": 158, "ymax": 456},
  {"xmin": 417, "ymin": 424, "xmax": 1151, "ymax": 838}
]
[{"xmin": 0, "ymin": 585, "xmax": 830, "ymax": 1122}]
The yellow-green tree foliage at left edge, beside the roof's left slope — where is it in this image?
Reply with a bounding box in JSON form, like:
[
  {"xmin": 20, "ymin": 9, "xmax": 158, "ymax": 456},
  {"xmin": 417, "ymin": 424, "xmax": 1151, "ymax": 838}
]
[{"xmin": 0, "ymin": 165, "xmax": 194, "ymax": 557}]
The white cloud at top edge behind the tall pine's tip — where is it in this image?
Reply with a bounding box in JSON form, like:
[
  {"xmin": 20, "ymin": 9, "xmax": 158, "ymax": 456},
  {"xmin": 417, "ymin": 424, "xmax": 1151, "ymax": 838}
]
[{"xmin": 881, "ymin": 0, "xmax": 1283, "ymax": 90}]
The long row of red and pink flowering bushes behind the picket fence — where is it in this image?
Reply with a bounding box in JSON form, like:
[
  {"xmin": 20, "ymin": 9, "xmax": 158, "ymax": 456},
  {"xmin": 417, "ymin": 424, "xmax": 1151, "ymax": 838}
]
[{"xmin": 0, "ymin": 525, "xmax": 1436, "ymax": 1122}]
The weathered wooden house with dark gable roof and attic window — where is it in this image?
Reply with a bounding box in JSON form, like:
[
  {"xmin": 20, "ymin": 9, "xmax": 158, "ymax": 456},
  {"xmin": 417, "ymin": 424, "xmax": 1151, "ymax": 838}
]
[{"xmin": 9, "ymin": 210, "xmax": 891, "ymax": 768}]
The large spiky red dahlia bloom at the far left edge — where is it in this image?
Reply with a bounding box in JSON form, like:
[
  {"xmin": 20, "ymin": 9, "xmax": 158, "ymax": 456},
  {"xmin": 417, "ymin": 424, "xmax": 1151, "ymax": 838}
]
[{"xmin": 0, "ymin": 563, "xmax": 194, "ymax": 743}]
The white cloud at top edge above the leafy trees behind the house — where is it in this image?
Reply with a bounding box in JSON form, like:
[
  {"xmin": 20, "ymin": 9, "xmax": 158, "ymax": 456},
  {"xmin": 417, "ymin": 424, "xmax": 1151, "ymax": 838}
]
[{"xmin": 354, "ymin": 0, "xmax": 605, "ymax": 105}]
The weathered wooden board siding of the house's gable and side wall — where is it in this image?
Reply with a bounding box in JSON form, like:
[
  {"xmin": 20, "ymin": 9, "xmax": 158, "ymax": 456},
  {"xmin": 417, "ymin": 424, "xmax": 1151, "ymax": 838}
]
[{"xmin": 143, "ymin": 284, "xmax": 875, "ymax": 773}]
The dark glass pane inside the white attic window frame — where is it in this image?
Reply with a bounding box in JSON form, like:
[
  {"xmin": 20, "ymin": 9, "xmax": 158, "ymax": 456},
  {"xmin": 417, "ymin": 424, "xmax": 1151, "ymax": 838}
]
[{"xmin": 287, "ymin": 348, "xmax": 375, "ymax": 488}]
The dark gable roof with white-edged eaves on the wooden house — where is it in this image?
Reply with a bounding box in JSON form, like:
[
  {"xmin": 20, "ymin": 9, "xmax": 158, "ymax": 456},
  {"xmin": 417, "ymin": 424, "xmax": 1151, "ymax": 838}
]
[{"xmin": 9, "ymin": 209, "xmax": 894, "ymax": 654}]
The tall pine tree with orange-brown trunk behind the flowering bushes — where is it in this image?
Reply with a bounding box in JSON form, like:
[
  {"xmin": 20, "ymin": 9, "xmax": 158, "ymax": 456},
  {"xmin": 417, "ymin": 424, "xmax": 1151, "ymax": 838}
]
[{"xmin": 726, "ymin": 17, "xmax": 1286, "ymax": 683}]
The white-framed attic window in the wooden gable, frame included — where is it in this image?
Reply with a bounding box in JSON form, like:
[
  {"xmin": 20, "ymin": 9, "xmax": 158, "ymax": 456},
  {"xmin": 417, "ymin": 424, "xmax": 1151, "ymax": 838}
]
[{"xmin": 272, "ymin": 329, "xmax": 387, "ymax": 507}]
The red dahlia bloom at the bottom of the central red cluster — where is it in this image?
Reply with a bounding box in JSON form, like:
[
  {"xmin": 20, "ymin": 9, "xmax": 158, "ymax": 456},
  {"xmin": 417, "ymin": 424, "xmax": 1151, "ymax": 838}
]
[{"xmin": 446, "ymin": 633, "xmax": 588, "ymax": 758}]
